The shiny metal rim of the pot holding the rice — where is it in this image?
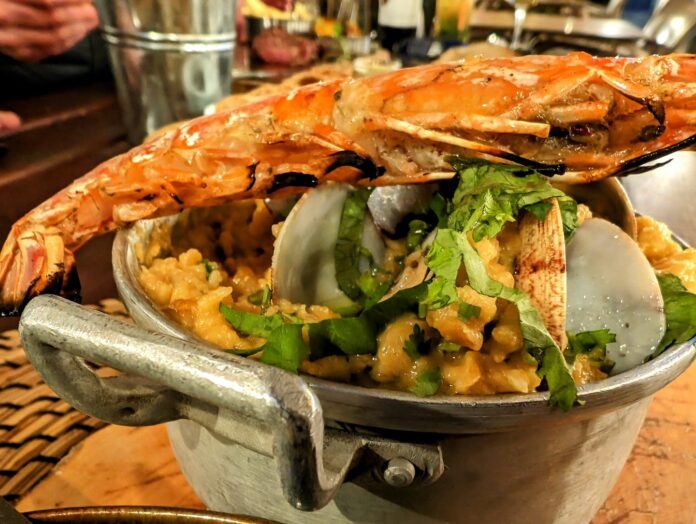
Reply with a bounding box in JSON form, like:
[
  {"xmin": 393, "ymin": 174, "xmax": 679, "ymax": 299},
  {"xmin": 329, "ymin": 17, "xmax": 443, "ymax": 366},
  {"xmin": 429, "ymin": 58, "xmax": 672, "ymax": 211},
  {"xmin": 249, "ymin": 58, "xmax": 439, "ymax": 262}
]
[{"xmin": 112, "ymin": 217, "xmax": 696, "ymax": 433}]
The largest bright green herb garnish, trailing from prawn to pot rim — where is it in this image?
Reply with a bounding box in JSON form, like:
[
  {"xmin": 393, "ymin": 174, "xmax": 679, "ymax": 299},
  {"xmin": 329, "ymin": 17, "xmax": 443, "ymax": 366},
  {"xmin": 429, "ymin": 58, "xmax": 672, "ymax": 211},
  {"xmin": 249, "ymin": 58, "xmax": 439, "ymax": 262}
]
[{"xmin": 424, "ymin": 158, "xmax": 577, "ymax": 410}]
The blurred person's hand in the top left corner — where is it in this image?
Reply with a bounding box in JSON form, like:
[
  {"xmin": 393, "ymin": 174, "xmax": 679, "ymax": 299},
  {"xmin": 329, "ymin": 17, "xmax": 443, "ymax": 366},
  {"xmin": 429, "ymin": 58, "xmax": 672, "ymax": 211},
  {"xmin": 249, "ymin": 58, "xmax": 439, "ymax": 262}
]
[{"xmin": 0, "ymin": 0, "xmax": 99, "ymax": 62}]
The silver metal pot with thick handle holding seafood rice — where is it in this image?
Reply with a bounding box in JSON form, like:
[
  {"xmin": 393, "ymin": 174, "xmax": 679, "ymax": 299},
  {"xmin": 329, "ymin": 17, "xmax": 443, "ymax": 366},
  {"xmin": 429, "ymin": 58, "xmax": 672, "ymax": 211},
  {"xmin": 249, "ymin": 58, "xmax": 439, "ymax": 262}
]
[{"xmin": 20, "ymin": 181, "xmax": 696, "ymax": 524}]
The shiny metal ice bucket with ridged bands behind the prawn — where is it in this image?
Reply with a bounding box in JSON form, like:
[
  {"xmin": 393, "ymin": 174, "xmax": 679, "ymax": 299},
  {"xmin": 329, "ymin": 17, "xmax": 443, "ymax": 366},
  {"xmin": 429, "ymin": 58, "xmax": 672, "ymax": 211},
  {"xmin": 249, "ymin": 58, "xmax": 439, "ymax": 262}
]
[{"xmin": 95, "ymin": 0, "xmax": 236, "ymax": 144}]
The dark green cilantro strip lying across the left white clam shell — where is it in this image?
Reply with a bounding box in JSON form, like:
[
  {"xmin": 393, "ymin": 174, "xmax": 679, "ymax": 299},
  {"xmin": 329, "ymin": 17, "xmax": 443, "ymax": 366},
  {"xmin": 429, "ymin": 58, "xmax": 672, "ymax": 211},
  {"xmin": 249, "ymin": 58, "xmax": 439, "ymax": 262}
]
[{"xmin": 334, "ymin": 188, "xmax": 372, "ymax": 300}]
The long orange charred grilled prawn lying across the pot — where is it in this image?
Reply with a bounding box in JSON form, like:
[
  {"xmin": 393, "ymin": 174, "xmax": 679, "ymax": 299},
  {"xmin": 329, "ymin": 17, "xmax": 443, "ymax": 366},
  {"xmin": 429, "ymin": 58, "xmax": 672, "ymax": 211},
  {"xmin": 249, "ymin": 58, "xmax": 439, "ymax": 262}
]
[{"xmin": 0, "ymin": 53, "xmax": 696, "ymax": 314}]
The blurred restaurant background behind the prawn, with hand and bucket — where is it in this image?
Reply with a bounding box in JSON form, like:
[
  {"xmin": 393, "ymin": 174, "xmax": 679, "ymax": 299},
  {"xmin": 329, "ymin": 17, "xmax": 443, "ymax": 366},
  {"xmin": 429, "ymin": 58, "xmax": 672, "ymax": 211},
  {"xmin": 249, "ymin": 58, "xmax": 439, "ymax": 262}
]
[{"xmin": 0, "ymin": 0, "xmax": 696, "ymax": 329}]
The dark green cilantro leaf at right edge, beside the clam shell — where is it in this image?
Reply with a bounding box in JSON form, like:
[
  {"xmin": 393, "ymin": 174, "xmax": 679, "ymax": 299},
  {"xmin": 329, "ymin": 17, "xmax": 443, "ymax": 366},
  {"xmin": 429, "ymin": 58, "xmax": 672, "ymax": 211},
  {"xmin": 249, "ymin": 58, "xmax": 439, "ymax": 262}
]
[{"xmin": 650, "ymin": 273, "xmax": 696, "ymax": 358}]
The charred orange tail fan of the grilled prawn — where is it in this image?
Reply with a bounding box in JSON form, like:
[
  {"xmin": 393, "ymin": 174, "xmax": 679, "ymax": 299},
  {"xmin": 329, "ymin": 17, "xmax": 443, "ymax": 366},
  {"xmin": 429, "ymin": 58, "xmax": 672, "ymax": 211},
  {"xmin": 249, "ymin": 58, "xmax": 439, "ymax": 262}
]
[{"xmin": 0, "ymin": 224, "xmax": 81, "ymax": 317}]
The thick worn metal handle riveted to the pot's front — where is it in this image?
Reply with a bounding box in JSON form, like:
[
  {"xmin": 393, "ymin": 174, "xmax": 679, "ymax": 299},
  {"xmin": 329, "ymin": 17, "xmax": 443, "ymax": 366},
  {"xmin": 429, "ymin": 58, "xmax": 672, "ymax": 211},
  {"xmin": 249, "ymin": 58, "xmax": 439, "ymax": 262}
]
[{"xmin": 19, "ymin": 296, "xmax": 444, "ymax": 510}]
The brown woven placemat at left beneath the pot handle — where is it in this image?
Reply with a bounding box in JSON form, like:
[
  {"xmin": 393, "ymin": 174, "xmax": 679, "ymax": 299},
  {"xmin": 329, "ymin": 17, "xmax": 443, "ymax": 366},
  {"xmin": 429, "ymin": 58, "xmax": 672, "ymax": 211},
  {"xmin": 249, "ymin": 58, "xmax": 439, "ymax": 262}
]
[{"xmin": 0, "ymin": 299, "xmax": 127, "ymax": 502}]
